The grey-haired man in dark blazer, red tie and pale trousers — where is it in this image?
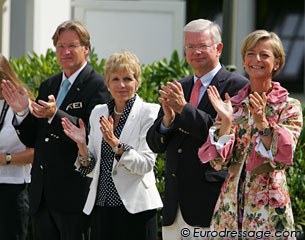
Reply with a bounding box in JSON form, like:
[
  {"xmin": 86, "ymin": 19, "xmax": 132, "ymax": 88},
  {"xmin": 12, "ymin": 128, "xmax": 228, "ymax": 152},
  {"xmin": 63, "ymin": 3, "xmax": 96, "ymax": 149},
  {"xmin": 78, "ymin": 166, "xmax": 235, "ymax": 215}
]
[{"xmin": 147, "ymin": 19, "xmax": 248, "ymax": 240}]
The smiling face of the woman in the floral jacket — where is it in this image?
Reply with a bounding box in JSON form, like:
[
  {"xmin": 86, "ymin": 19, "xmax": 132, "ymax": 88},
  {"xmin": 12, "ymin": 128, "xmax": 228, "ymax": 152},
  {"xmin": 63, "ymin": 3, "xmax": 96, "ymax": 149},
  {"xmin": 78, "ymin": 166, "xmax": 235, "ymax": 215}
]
[{"xmin": 244, "ymin": 40, "xmax": 279, "ymax": 81}]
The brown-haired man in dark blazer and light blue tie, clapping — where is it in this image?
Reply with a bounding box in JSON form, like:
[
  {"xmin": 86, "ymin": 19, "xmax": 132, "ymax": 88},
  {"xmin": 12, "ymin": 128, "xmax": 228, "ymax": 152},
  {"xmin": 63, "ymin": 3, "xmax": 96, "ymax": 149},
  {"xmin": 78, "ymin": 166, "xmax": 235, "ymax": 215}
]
[{"xmin": 2, "ymin": 21, "xmax": 110, "ymax": 240}]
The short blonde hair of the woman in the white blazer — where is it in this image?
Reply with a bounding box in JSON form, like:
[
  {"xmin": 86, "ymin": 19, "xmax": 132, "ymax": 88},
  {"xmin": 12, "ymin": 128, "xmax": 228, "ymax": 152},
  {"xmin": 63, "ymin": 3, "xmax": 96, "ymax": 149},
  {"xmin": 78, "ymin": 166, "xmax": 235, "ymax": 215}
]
[{"xmin": 104, "ymin": 52, "xmax": 141, "ymax": 87}]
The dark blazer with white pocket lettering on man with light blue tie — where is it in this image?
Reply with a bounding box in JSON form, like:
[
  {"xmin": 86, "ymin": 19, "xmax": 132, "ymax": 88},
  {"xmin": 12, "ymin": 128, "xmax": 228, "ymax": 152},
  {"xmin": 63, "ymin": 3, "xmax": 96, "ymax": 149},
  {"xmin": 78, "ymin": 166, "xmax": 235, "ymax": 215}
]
[{"xmin": 15, "ymin": 64, "xmax": 110, "ymax": 214}]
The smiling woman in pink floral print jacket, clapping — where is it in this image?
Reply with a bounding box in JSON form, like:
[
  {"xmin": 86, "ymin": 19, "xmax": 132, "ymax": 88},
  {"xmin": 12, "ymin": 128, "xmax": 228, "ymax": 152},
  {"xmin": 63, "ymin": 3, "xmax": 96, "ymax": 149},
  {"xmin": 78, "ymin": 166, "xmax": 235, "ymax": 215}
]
[{"xmin": 198, "ymin": 30, "xmax": 303, "ymax": 239}]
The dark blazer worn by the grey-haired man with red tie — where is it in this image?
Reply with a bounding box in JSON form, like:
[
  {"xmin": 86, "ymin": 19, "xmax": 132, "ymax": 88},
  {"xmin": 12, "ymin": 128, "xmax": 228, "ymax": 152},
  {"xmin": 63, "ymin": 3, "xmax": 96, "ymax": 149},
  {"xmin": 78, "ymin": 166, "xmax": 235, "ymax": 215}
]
[{"xmin": 147, "ymin": 67, "xmax": 248, "ymax": 227}]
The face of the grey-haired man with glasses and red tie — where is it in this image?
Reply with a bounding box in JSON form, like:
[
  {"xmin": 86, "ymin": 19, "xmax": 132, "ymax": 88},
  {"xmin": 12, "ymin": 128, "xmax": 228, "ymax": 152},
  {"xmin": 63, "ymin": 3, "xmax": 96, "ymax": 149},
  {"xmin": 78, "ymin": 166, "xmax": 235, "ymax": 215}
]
[{"xmin": 184, "ymin": 30, "xmax": 222, "ymax": 77}]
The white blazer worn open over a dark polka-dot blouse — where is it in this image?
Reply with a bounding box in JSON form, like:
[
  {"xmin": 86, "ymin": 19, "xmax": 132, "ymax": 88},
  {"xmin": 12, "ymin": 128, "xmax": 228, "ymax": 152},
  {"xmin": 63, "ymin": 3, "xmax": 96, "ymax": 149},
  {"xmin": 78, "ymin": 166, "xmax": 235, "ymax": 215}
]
[{"xmin": 75, "ymin": 96, "xmax": 163, "ymax": 215}]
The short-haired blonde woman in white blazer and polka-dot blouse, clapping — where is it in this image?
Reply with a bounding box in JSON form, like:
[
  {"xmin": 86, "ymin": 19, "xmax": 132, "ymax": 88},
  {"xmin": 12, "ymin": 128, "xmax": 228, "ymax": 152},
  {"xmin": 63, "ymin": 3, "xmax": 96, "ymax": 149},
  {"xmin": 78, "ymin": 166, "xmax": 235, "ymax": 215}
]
[{"xmin": 62, "ymin": 52, "xmax": 162, "ymax": 240}]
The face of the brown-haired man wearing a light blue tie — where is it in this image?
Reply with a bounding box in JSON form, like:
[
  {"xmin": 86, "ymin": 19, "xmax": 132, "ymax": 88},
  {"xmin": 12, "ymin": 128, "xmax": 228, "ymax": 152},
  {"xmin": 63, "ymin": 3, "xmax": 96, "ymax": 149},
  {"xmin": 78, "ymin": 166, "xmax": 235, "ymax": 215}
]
[{"xmin": 56, "ymin": 30, "xmax": 89, "ymax": 77}]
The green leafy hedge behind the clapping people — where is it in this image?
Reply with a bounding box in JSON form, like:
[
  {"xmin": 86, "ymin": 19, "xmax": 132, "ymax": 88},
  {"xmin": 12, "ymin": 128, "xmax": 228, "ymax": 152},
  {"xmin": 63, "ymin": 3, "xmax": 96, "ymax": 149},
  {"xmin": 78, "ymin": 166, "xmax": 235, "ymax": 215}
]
[{"xmin": 10, "ymin": 49, "xmax": 305, "ymax": 238}]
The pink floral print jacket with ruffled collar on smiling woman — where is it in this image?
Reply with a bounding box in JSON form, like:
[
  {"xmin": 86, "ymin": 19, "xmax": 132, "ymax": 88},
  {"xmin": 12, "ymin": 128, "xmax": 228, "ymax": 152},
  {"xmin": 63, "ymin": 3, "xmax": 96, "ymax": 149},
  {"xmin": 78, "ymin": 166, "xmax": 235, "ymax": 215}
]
[{"xmin": 198, "ymin": 82, "xmax": 303, "ymax": 238}]
